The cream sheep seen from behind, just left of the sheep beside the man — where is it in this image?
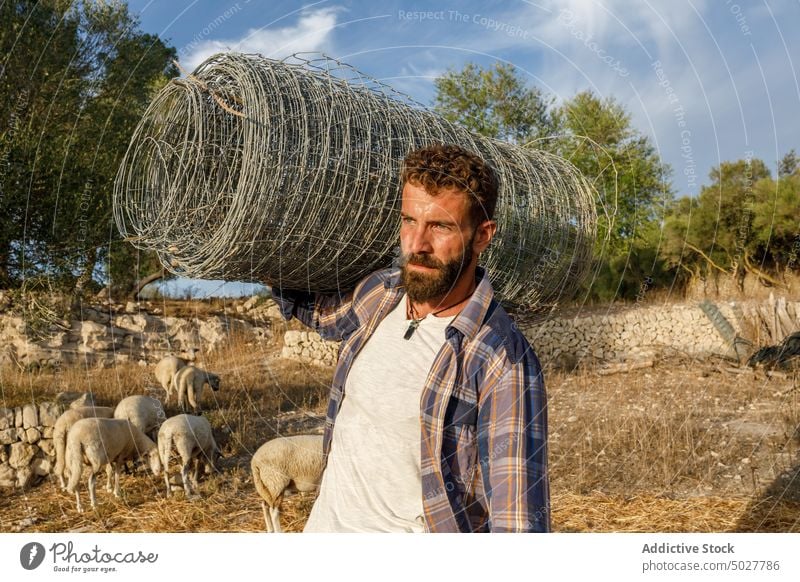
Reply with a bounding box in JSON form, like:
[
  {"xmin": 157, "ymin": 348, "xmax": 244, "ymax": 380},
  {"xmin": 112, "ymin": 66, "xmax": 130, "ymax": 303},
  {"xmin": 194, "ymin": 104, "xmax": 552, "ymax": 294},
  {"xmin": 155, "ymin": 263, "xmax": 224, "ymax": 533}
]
[{"xmin": 158, "ymin": 414, "xmax": 222, "ymax": 497}]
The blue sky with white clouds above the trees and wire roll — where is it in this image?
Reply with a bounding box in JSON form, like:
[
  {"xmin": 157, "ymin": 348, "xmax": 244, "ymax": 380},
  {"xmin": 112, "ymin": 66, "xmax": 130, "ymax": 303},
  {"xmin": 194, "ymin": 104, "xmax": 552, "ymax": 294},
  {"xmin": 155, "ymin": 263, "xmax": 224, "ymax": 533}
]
[{"xmin": 129, "ymin": 0, "xmax": 800, "ymax": 298}]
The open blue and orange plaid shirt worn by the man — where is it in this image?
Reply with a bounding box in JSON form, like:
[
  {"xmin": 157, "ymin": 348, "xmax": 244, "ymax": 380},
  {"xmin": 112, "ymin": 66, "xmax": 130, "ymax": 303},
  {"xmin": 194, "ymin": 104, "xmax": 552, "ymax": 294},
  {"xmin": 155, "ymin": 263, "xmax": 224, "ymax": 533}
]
[{"xmin": 274, "ymin": 268, "xmax": 550, "ymax": 532}]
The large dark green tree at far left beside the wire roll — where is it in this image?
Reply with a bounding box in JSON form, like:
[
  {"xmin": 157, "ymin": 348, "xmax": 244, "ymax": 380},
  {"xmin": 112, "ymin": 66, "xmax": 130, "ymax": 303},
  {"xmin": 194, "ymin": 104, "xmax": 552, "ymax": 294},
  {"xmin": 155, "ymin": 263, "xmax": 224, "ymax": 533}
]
[{"xmin": 0, "ymin": 0, "xmax": 177, "ymax": 290}]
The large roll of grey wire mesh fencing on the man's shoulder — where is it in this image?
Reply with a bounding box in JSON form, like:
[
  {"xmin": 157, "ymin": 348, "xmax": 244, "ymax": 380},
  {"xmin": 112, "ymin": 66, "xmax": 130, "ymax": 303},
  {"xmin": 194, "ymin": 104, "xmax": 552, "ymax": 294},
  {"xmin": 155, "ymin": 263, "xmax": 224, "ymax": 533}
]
[{"xmin": 114, "ymin": 53, "xmax": 597, "ymax": 306}]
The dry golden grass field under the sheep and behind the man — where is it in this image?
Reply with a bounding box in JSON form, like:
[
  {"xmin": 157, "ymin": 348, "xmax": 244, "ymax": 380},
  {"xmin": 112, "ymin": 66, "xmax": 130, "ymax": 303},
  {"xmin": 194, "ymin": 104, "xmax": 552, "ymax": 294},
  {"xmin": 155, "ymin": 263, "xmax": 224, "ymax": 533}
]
[{"xmin": 0, "ymin": 338, "xmax": 800, "ymax": 532}]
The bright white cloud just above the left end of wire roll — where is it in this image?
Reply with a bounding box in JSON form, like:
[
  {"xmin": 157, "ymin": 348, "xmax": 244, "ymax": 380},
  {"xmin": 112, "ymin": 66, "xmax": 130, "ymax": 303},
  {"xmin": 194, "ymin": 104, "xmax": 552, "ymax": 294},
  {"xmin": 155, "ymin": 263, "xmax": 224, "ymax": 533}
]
[{"xmin": 181, "ymin": 7, "xmax": 340, "ymax": 71}]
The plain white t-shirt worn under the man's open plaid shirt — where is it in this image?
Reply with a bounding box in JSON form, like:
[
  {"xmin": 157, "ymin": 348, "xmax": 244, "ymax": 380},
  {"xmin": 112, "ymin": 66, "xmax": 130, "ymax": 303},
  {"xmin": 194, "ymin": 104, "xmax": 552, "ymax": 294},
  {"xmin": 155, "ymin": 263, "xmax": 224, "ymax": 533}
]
[{"xmin": 304, "ymin": 298, "xmax": 455, "ymax": 532}]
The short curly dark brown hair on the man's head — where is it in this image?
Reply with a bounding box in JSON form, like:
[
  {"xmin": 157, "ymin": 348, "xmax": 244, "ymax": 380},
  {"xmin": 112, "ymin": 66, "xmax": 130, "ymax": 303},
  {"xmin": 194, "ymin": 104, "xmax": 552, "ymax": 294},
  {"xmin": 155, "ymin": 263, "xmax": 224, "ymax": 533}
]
[{"xmin": 401, "ymin": 144, "xmax": 499, "ymax": 226}]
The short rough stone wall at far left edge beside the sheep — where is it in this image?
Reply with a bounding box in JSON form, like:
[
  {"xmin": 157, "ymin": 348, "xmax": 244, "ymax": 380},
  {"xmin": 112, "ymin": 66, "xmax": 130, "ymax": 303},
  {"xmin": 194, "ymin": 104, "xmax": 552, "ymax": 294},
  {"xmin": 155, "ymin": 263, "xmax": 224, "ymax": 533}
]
[{"xmin": 0, "ymin": 402, "xmax": 64, "ymax": 487}]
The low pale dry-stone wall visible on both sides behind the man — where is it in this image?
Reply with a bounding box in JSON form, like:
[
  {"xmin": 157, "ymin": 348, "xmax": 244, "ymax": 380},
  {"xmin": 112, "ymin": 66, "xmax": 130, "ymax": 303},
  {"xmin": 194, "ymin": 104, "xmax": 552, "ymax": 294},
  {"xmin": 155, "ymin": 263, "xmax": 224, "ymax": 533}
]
[{"xmin": 282, "ymin": 300, "xmax": 800, "ymax": 367}]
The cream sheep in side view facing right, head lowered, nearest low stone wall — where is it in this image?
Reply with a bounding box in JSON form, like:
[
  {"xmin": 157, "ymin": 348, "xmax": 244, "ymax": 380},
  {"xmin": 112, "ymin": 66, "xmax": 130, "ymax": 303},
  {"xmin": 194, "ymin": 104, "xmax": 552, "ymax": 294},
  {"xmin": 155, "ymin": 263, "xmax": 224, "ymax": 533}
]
[{"xmin": 66, "ymin": 418, "xmax": 161, "ymax": 512}]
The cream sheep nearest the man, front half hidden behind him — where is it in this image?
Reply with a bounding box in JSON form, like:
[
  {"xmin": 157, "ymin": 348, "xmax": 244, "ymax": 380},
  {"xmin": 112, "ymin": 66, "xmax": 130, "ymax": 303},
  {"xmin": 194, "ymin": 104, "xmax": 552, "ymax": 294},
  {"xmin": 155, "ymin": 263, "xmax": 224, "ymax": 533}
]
[{"xmin": 250, "ymin": 435, "xmax": 324, "ymax": 532}]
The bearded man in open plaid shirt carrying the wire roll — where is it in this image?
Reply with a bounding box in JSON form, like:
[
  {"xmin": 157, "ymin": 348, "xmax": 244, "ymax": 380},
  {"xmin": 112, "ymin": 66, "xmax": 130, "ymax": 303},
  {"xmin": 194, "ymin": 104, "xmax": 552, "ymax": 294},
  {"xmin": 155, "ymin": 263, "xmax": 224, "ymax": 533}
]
[{"xmin": 273, "ymin": 145, "xmax": 550, "ymax": 532}]
